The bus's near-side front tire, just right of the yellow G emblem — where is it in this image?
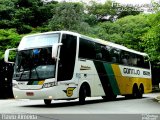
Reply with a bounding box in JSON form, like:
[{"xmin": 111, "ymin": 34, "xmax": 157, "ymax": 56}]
[{"xmin": 79, "ymin": 86, "xmax": 87, "ymax": 105}]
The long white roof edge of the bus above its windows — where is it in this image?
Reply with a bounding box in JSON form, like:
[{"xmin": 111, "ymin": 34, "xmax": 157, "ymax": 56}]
[{"xmin": 24, "ymin": 30, "xmax": 148, "ymax": 56}]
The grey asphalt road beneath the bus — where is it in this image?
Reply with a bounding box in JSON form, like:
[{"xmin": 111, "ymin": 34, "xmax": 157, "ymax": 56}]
[{"xmin": 0, "ymin": 93, "xmax": 160, "ymax": 120}]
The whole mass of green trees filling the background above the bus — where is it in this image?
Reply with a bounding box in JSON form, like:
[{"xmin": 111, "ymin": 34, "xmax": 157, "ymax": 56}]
[{"xmin": 0, "ymin": 0, "xmax": 160, "ymax": 66}]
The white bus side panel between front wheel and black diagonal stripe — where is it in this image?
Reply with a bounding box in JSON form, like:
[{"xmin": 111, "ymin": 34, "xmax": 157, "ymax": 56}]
[{"xmin": 75, "ymin": 59, "xmax": 105, "ymax": 97}]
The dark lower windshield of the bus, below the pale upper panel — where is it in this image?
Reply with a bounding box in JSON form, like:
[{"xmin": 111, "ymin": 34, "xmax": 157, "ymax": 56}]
[{"xmin": 13, "ymin": 47, "xmax": 55, "ymax": 81}]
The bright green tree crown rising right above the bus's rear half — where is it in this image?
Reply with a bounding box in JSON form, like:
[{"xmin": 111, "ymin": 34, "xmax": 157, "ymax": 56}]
[{"xmin": 87, "ymin": 14, "xmax": 150, "ymax": 52}]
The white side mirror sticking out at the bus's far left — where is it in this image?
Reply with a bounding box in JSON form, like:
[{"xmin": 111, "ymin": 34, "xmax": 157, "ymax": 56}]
[{"xmin": 4, "ymin": 48, "xmax": 17, "ymax": 64}]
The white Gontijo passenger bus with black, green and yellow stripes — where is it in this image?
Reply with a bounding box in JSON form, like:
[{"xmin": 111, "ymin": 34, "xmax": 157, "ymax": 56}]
[{"xmin": 5, "ymin": 31, "xmax": 152, "ymax": 105}]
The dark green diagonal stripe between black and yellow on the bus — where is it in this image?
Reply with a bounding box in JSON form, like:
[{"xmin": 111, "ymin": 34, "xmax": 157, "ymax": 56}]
[{"xmin": 103, "ymin": 63, "xmax": 120, "ymax": 95}]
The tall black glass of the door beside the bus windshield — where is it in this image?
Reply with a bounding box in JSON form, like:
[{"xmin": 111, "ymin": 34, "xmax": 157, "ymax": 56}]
[{"xmin": 58, "ymin": 34, "xmax": 77, "ymax": 81}]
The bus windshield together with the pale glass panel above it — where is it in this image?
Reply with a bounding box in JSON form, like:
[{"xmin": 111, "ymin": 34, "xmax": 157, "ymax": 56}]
[{"xmin": 13, "ymin": 34, "xmax": 59, "ymax": 81}]
